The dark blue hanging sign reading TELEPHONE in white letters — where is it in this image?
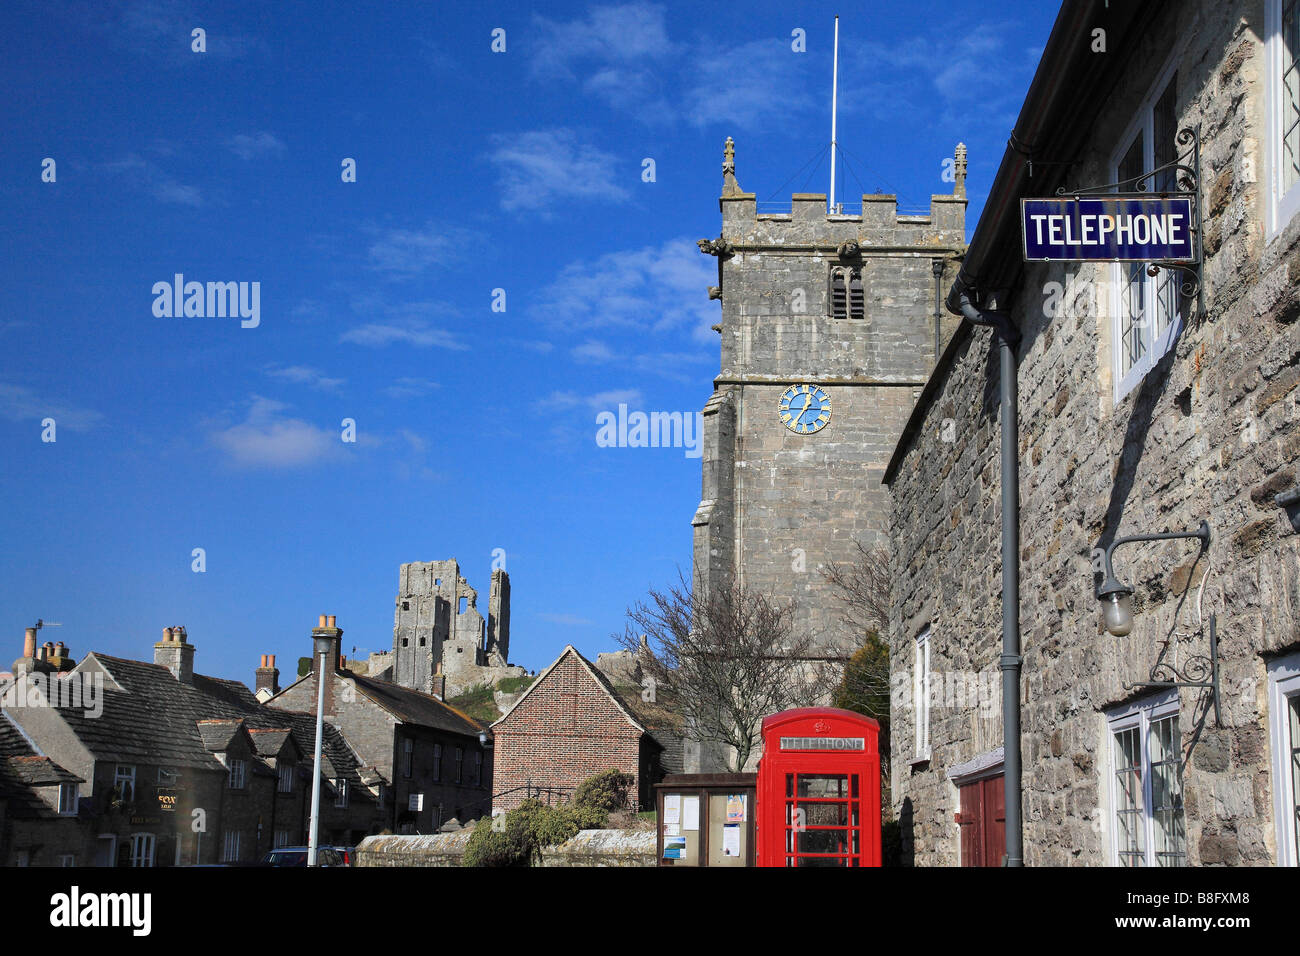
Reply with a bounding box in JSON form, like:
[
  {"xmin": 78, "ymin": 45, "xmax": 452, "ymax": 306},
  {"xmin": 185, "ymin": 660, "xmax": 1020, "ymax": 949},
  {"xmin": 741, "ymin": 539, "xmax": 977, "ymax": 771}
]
[{"xmin": 1021, "ymin": 196, "xmax": 1196, "ymax": 263}]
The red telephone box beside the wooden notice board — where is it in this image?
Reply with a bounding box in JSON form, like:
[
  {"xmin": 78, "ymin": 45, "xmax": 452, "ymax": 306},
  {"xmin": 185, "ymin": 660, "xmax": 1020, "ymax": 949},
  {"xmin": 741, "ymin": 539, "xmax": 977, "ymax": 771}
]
[{"xmin": 755, "ymin": 708, "xmax": 880, "ymax": 866}]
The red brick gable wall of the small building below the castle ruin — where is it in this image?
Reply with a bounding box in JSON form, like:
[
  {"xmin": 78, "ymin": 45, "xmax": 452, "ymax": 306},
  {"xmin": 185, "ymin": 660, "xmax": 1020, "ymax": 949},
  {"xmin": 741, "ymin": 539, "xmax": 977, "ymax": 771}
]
[{"xmin": 493, "ymin": 652, "xmax": 641, "ymax": 810}]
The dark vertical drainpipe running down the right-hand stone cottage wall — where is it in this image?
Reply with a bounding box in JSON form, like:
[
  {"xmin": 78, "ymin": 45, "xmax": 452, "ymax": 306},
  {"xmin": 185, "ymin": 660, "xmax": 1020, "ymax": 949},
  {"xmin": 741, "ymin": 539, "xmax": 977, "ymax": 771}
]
[{"xmin": 954, "ymin": 289, "xmax": 1024, "ymax": 866}]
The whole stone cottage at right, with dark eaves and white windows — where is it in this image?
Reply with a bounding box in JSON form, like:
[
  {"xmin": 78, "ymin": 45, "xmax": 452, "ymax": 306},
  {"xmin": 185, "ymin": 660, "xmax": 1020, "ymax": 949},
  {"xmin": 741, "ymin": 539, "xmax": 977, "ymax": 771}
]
[{"xmin": 885, "ymin": 0, "xmax": 1300, "ymax": 866}]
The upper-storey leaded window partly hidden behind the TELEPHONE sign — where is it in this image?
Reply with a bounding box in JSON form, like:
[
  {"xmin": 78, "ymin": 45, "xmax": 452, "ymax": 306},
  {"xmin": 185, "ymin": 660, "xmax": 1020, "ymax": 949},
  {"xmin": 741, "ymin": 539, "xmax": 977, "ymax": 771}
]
[{"xmin": 1110, "ymin": 73, "xmax": 1183, "ymax": 402}]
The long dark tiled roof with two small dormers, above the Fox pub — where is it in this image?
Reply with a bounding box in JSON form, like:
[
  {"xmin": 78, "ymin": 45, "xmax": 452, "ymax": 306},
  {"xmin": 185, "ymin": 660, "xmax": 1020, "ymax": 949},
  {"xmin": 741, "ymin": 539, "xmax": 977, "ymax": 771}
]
[{"xmin": 39, "ymin": 652, "xmax": 364, "ymax": 796}]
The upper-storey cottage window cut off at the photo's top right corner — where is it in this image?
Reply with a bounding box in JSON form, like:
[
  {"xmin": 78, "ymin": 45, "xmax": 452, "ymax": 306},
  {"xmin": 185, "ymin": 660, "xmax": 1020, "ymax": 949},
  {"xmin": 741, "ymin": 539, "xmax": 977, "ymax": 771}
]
[{"xmin": 1265, "ymin": 0, "xmax": 1300, "ymax": 237}]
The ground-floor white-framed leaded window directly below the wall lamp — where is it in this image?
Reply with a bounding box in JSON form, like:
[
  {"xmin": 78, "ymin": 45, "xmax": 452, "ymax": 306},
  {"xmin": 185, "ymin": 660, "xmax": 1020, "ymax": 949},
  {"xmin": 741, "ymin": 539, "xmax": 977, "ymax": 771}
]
[{"xmin": 1108, "ymin": 691, "xmax": 1187, "ymax": 866}]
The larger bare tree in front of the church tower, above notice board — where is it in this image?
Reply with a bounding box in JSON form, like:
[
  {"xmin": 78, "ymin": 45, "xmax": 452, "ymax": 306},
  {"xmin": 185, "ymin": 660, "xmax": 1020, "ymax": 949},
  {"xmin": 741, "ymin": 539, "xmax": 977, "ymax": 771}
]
[{"xmin": 618, "ymin": 574, "xmax": 832, "ymax": 771}]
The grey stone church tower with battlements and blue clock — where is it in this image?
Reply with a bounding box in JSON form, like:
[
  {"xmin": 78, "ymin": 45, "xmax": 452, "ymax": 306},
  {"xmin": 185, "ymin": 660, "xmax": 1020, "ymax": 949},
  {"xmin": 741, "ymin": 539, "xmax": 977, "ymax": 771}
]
[{"xmin": 692, "ymin": 138, "xmax": 966, "ymax": 659}]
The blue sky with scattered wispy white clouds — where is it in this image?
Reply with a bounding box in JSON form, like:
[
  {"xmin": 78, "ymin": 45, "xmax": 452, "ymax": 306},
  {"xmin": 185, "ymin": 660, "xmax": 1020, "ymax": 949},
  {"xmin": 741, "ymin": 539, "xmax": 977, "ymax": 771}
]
[{"xmin": 0, "ymin": 0, "xmax": 1056, "ymax": 682}]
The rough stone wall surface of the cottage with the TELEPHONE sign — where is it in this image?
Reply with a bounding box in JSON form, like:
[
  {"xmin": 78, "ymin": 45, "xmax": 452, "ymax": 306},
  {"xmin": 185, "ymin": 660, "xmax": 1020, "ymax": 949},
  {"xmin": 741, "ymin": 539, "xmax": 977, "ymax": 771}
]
[{"xmin": 891, "ymin": 1, "xmax": 1300, "ymax": 865}]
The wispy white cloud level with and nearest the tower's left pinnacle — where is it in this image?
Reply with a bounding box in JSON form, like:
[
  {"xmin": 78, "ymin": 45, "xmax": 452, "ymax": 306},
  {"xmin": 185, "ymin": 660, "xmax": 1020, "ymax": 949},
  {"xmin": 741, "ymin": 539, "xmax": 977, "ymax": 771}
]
[{"xmin": 489, "ymin": 129, "xmax": 628, "ymax": 213}]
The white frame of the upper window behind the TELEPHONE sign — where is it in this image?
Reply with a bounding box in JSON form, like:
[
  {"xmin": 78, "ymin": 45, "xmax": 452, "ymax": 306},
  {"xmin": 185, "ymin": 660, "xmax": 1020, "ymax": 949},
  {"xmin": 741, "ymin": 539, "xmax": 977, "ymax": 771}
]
[{"xmin": 1106, "ymin": 55, "xmax": 1204, "ymax": 405}]
